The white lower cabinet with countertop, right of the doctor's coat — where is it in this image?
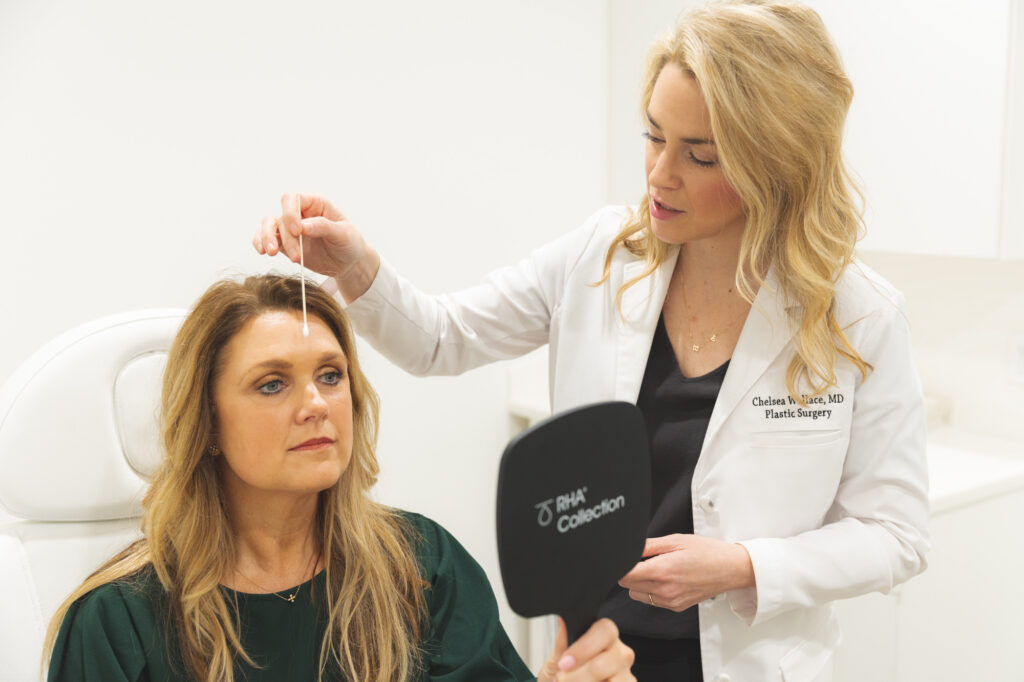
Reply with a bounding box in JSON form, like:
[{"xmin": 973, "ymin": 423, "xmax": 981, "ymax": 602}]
[{"xmin": 836, "ymin": 444, "xmax": 1024, "ymax": 682}]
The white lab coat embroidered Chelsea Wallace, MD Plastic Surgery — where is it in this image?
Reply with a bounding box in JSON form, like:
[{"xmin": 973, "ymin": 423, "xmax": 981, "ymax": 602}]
[{"xmin": 347, "ymin": 207, "xmax": 928, "ymax": 682}]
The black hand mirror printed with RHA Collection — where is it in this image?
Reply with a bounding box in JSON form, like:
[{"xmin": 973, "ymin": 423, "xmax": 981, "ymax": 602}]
[{"xmin": 498, "ymin": 402, "xmax": 650, "ymax": 642}]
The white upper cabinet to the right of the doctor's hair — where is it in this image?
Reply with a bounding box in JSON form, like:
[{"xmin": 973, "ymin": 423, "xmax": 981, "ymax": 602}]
[{"xmin": 809, "ymin": 0, "xmax": 1024, "ymax": 256}]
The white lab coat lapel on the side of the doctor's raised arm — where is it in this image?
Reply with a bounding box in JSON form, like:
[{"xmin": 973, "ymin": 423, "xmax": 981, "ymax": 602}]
[{"xmin": 614, "ymin": 247, "xmax": 679, "ymax": 402}]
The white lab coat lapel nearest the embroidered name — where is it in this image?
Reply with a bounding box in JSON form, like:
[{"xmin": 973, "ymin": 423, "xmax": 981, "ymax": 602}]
[{"xmin": 694, "ymin": 268, "xmax": 797, "ymax": 466}]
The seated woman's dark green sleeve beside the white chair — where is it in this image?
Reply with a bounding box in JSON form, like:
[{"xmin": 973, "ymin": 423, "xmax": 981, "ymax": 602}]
[{"xmin": 47, "ymin": 585, "xmax": 145, "ymax": 682}]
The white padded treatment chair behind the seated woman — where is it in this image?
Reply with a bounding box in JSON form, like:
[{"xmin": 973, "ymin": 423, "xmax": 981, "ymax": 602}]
[{"xmin": 0, "ymin": 309, "xmax": 185, "ymax": 682}]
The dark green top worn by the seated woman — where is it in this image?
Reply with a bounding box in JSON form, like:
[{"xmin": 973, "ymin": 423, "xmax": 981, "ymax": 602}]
[{"xmin": 48, "ymin": 512, "xmax": 535, "ymax": 682}]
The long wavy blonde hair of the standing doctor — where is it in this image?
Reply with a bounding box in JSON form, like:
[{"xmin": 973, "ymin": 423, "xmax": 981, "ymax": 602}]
[{"xmin": 600, "ymin": 0, "xmax": 869, "ymax": 403}]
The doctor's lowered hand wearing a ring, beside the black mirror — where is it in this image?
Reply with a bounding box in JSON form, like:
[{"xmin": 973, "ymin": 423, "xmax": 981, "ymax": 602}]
[{"xmin": 618, "ymin": 534, "xmax": 754, "ymax": 611}]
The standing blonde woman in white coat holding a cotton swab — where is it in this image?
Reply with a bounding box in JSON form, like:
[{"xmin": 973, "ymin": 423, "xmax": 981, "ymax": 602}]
[{"xmin": 254, "ymin": 0, "xmax": 928, "ymax": 682}]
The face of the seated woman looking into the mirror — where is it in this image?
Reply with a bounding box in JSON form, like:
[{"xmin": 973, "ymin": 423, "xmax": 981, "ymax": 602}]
[{"xmin": 213, "ymin": 311, "xmax": 352, "ymax": 501}]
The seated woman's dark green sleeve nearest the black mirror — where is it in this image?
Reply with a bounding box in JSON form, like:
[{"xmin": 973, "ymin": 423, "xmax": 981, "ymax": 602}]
[{"xmin": 409, "ymin": 514, "xmax": 536, "ymax": 682}]
